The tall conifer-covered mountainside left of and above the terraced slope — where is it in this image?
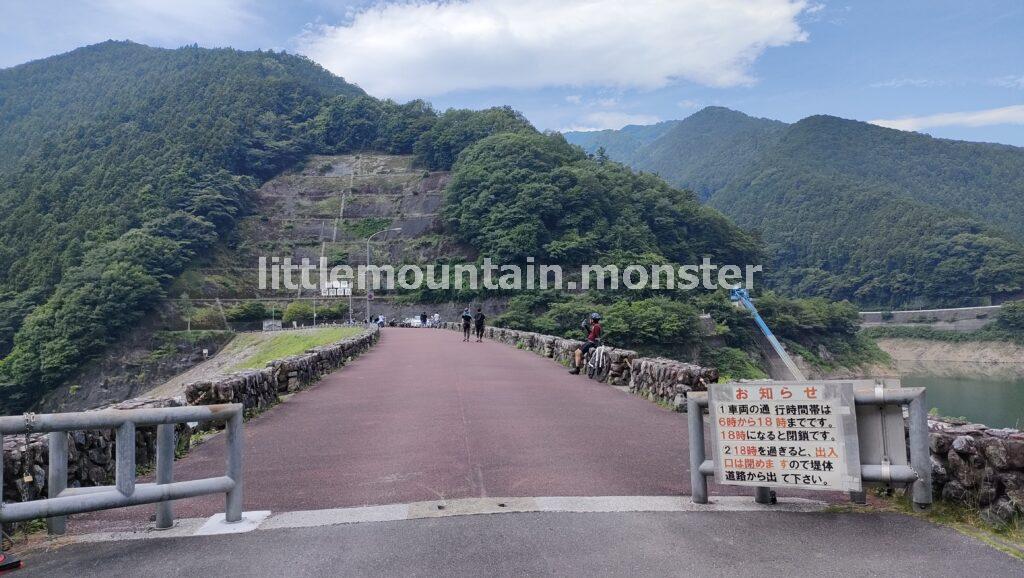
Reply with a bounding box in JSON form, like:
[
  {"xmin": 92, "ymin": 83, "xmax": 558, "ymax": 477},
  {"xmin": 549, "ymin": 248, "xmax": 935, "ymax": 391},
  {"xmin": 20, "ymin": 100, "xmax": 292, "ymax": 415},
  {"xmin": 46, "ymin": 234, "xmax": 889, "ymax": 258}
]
[{"xmin": 0, "ymin": 42, "xmax": 532, "ymax": 408}]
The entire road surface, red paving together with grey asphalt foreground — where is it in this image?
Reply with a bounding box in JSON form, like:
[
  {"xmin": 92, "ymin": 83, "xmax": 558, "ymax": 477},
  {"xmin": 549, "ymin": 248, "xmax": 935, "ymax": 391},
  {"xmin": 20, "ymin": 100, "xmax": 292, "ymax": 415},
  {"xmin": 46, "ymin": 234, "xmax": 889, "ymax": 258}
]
[{"xmin": 24, "ymin": 329, "xmax": 1024, "ymax": 576}]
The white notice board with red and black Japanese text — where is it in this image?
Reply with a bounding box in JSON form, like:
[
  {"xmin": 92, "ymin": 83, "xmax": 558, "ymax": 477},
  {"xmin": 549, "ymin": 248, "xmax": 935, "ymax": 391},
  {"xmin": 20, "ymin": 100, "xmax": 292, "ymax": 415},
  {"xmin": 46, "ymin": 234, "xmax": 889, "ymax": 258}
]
[{"xmin": 708, "ymin": 381, "xmax": 860, "ymax": 492}]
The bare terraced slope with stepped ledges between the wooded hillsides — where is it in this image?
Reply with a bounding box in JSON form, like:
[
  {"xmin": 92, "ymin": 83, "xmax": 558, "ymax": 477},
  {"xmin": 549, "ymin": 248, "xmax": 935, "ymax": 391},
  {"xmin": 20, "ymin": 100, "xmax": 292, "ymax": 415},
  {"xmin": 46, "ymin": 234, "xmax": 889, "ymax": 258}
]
[{"xmin": 187, "ymin": 154, "xmax": 468, "ymax": 299}]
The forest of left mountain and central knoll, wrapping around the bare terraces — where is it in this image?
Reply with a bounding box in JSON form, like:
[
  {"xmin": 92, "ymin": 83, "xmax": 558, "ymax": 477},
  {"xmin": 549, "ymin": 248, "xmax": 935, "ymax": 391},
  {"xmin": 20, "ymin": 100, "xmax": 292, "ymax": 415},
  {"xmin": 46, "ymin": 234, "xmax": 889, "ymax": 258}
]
[{"xmin": 0, "ymin": 42, "xmax": 760, "ymax": 412}]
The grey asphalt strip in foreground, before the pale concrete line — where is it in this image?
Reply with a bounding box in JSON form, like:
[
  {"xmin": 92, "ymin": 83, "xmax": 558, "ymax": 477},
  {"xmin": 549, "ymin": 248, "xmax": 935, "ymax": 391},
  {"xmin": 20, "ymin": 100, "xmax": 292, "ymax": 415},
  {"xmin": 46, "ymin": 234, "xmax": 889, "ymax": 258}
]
[{"xmin": 16, "ymin": 512, "xmax": 1024, "ymax": 578}]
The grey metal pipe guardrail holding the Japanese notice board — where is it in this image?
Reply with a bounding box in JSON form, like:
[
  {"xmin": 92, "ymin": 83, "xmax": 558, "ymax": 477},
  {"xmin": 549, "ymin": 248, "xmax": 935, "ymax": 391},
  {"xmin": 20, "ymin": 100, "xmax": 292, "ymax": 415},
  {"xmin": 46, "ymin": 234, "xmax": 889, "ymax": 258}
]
[{"xmin": 686, "ymin": 386, "xmax": 932, "ymax": 509}]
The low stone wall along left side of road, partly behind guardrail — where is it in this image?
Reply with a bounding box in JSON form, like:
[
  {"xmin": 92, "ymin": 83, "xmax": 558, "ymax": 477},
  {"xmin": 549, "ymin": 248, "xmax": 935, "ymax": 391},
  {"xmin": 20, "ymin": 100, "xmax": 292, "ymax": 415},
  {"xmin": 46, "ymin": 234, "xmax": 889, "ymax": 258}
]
[{"xmin": 3, "ymin": 326, "xmax": 380, "ymax": 510}]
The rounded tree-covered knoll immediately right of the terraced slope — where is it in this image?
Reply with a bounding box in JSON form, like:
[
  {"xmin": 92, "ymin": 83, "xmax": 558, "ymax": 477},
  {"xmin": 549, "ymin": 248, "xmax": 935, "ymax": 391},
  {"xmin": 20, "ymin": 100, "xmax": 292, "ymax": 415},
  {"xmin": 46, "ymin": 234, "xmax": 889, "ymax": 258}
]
[{"xmin": 444, "ymin": 132, "xmax": 759, "ymax": 264}]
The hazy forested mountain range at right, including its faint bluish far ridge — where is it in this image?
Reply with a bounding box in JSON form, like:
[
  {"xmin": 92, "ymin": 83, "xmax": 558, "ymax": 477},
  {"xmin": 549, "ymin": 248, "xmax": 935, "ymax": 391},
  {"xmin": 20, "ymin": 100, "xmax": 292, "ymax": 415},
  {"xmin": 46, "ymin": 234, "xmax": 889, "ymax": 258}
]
[{"xmin": 565, "ymin": 107, "xmax": 1024, "ymax": 307}]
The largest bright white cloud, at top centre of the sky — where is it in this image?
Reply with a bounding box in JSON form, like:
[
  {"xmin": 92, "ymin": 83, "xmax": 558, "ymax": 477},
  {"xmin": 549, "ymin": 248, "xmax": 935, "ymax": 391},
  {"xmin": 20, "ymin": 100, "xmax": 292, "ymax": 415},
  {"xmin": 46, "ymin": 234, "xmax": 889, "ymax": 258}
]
[{"xmin": 297, "ymin": 0, "xmax": 808, "ymax": 98}]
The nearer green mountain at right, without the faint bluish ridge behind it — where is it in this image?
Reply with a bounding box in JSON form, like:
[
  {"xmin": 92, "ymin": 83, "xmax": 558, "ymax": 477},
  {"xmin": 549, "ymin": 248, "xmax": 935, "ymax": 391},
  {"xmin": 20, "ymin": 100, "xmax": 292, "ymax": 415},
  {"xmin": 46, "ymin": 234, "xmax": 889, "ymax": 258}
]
[{"xmin": 710, "ymin": 117, "xmax": 1024, "ymax": 307}]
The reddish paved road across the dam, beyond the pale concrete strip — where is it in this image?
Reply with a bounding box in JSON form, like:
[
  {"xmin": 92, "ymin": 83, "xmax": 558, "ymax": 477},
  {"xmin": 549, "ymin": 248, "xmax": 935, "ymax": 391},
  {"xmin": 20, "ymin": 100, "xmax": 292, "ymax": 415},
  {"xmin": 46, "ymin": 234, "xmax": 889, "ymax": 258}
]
[{"xmin": 73, "ymin": 329, "xmax": 806, "ymax": 528}]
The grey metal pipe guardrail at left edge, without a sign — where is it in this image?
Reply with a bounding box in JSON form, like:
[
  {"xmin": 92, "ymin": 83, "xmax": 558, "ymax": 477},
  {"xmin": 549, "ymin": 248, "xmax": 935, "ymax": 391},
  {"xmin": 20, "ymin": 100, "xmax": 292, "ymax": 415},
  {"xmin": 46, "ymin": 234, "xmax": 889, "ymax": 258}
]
[{"xmin": 0, "ymin": 404, "xmax": 243, "ymax": 534}]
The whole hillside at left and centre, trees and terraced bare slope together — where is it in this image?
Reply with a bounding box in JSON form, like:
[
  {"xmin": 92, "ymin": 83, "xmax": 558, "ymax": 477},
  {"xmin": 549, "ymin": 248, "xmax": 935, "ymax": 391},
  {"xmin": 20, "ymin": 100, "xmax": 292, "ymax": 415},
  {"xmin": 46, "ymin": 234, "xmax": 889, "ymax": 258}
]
[{"xmin": 0, "ymin": 42, "xmax": 760, "ymax": 412}]
